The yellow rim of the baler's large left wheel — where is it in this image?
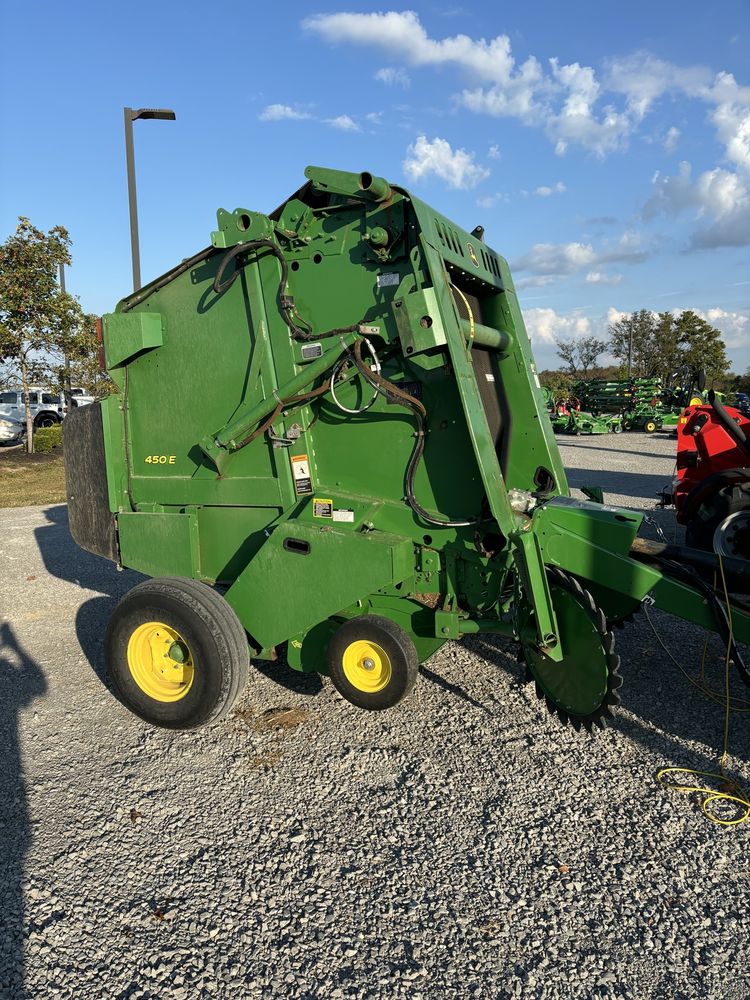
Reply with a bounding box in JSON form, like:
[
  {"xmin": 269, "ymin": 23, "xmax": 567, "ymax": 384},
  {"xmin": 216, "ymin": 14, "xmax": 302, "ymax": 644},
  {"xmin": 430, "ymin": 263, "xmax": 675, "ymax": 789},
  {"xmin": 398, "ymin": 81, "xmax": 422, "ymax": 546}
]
[{"xmin": 127, "ymin": 622, "xmax": 195, "ymax": 702}]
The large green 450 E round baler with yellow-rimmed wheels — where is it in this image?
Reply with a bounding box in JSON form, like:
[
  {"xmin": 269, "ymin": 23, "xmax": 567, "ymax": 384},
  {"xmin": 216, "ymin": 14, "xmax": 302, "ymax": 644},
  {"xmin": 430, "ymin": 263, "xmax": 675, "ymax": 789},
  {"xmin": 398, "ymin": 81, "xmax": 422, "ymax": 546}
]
[{"xmin": 65, "ymin": 167, "xmax": 750, "ymax": 729}]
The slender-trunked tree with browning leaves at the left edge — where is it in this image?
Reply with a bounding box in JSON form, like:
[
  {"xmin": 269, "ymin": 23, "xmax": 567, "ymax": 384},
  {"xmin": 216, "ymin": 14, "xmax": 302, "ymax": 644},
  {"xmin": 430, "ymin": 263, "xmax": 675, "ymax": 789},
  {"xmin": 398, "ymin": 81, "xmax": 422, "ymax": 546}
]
[{"xmin": 0, "ymin": 222, "xmax": 71, "ymax": 452}]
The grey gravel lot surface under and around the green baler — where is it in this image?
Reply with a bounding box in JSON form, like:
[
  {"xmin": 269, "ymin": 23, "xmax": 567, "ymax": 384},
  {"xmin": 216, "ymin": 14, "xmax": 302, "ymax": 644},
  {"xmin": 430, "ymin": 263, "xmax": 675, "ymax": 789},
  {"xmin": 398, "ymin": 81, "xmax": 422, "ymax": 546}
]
[{"xmin": 0, "ymin": 434, "xmax": 750, "ymax": 1000}]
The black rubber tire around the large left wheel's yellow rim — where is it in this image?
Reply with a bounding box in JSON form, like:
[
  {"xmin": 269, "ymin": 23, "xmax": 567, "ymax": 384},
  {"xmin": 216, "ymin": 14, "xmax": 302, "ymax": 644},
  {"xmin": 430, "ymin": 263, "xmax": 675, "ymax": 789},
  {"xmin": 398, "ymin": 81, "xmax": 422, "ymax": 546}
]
[{"xmin": 105, "ymin": 577, "xmax": 250, "ymax": 729}]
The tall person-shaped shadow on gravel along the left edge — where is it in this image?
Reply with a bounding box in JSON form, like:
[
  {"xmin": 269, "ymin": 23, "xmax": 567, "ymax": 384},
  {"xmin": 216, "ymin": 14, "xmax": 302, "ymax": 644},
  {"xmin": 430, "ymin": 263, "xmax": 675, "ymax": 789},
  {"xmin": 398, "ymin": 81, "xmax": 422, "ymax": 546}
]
[{"xmin": 0, "ymin": 624, "xmax": 47, "ymax": 1000}]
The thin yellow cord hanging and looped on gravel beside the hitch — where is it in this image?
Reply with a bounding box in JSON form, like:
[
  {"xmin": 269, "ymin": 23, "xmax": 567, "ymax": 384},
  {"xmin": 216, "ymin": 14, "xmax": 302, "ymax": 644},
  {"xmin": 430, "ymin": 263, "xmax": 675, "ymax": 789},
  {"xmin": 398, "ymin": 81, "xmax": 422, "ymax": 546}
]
[{"xmin": 644, "ymin": 555, "xmax": 750, "ymax": 826}]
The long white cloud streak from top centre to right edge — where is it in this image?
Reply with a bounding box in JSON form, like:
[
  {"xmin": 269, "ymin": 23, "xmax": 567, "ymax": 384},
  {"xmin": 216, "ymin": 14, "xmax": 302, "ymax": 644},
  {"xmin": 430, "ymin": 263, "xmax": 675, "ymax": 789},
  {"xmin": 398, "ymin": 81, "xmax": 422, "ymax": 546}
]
[{"xmin": 302, "ymin": 11, "xmax": 750, "ymax": 172}]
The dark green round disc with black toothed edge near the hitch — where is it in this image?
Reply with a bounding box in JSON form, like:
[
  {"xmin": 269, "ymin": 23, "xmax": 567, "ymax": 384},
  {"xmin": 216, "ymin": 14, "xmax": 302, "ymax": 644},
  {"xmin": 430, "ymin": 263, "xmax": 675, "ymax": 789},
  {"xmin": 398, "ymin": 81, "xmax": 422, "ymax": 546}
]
[{"xmin": 519, "ymin": 568, "xmax": 622, "ymax": 732}]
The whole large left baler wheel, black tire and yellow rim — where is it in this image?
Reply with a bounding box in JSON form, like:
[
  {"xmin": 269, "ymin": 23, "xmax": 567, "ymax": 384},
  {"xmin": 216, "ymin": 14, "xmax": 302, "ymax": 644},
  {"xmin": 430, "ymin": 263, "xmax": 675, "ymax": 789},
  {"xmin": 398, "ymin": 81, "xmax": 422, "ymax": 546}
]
[{"xmin": 105, "ymin": 577, "xmax": 250, "ymax": 729}]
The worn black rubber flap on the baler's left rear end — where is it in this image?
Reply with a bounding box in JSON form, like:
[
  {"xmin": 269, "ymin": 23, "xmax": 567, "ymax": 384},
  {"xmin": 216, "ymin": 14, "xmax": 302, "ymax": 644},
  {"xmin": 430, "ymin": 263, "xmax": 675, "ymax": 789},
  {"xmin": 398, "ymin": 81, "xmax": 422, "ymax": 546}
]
[{"xmin": 63, "ymin": 402, "xmax": 118, "ymax": 562}]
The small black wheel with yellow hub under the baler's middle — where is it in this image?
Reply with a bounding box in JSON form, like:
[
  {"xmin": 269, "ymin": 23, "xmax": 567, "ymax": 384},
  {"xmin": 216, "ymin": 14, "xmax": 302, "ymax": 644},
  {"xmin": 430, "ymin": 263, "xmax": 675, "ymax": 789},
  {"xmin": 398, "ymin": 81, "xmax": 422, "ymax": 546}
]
[{"xmin": 328, "ymin": 615, "xmax": 419, "ymax": 711}]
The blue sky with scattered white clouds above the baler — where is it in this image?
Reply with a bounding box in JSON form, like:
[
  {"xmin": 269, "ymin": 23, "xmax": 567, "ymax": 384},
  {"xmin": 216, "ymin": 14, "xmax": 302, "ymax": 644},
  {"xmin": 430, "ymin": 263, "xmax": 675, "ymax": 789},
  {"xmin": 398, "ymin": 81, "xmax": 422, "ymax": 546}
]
[{"xmin": 0, "ymin": 0, "xmax": 750, "ymax": 371}]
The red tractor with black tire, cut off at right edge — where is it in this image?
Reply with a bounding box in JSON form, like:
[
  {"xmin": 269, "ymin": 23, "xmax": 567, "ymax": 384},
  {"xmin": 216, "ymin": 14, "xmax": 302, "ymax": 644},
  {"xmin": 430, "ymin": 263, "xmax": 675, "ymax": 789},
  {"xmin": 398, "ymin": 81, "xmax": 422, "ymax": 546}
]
[{"xmin": 671, "ymin": 390, "xmax": 750, "ymax": 559}]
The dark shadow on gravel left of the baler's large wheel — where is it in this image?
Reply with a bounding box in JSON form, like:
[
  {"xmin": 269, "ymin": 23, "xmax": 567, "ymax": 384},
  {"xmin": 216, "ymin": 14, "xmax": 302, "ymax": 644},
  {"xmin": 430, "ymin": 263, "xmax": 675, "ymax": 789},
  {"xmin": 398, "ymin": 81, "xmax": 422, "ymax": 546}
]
[{"xmin": 35, "ymin": 504, "xmax": 144, "ymax": 687}]
